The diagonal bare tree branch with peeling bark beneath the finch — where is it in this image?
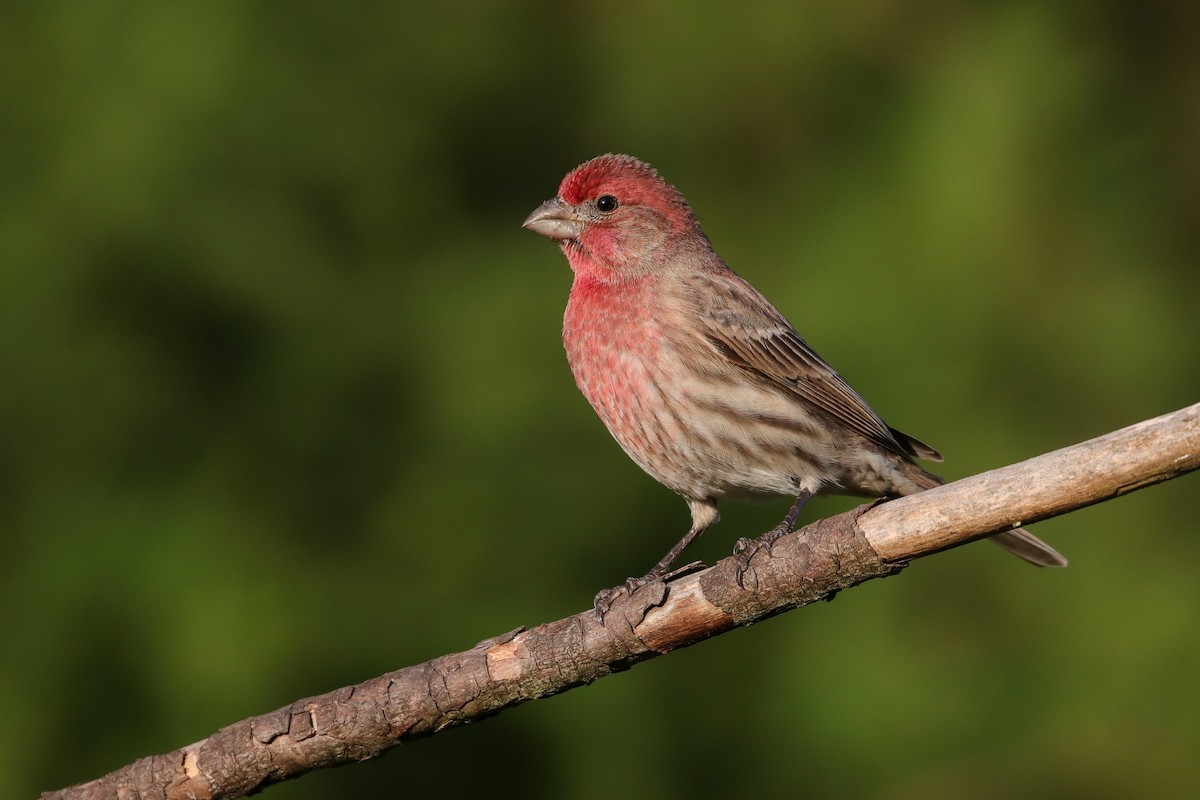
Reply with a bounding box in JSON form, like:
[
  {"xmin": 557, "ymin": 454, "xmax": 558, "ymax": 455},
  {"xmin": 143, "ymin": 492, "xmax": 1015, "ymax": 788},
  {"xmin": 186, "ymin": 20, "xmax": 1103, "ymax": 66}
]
[{"xmin": 42, "ymin": 403, "xmax": 1200, "ymax": 800}]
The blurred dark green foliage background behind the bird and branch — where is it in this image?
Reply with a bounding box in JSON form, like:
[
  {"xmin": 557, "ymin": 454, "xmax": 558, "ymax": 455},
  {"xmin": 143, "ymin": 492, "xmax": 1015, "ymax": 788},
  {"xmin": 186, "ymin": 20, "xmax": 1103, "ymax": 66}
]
[{"xmin": 0, "ymin": 0, "xmax": 1200, "ymax": 800}]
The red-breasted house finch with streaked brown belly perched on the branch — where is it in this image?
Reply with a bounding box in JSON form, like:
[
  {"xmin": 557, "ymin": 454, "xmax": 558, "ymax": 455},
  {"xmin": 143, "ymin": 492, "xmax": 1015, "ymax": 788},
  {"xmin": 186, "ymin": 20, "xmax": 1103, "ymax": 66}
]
[{"xmin": 523, "ymin": 155, "xmax": 1067, "ymax": 603}]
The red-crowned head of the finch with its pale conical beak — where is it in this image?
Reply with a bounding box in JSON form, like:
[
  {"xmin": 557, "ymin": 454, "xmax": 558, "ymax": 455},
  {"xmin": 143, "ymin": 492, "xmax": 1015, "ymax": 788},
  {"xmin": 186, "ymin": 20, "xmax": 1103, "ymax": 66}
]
[{"xmin": 524, "ymin": 154, "xmax": 709, "ymax": 282}]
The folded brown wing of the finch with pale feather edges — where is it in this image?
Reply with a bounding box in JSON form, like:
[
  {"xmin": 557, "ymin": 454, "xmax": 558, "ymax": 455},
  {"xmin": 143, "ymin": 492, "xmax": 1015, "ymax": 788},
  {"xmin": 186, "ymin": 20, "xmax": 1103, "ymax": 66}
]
[{"xmin": 694, "ymin": 272, "xmax": 942, "ymax": 461}]
